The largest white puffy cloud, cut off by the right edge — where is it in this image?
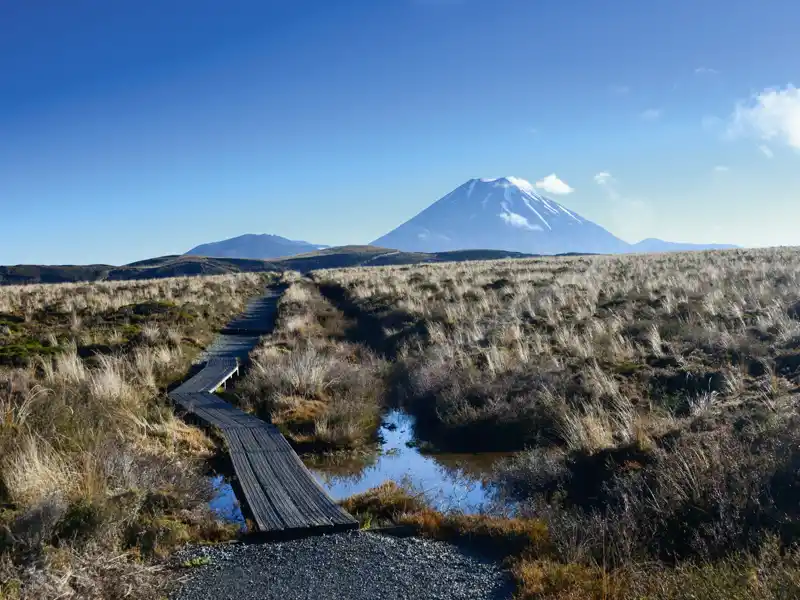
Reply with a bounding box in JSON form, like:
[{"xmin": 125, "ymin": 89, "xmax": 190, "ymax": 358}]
[{"xmin": 728, "ymin": 84, "xmax": 800, "ymax": 150}]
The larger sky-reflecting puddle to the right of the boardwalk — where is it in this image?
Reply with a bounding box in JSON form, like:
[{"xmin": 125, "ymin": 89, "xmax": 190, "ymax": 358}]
[{"xmin": 308, "ymin": 411, "xmax": 509, "ymax": 513}]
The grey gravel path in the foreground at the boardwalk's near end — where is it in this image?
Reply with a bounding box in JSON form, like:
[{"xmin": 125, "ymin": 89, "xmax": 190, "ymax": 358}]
[{"xmin": 173, "ymin": 532, "xmax": 512, "ymax": 600}]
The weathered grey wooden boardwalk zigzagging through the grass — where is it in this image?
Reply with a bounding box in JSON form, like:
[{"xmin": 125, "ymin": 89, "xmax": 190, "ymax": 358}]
[{"xmin": 169, "ymin": 290, "xmax": 358, "ymax": 536}]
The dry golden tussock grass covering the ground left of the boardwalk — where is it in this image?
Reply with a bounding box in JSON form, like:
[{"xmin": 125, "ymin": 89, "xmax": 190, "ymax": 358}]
[{"xmin": 0, "ymin": 275, "xmax": 262, "ymax": 599}]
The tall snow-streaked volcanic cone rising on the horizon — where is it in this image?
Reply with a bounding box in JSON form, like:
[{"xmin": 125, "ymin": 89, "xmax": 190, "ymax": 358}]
[{"xmin": 372, "ymin": 177, "xmax": 630, "ymax": 254}]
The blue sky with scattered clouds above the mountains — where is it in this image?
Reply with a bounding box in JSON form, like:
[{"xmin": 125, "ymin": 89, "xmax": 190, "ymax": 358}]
[{"xmin": 0, "ymin": 0, "xmax": 800, "ymax": 264}]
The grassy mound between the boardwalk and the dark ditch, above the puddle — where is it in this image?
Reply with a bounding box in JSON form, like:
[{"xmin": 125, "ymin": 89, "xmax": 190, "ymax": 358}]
[{"xmin": 238, "ymin": 281, "xmax": 385, "ymax": 451}]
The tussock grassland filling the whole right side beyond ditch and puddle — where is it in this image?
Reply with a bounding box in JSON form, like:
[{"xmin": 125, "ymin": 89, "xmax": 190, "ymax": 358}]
[{"xmin": 313, "ymin": 248, "xmax": 800, "ymax": 599}]
